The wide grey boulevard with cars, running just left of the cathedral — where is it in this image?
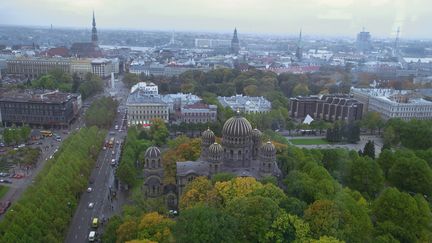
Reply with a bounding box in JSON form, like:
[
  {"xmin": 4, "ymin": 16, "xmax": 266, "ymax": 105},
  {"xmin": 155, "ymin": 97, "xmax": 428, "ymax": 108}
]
[{"xmin": 65, "ymin": 75, "xmax": 128, "ymax": 243}]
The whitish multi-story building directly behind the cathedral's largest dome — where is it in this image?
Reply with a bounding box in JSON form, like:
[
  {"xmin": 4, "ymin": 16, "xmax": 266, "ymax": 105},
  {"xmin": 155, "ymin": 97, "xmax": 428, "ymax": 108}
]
[{"xmin": 218, "ymin": 94, "xmax": 271, "ymax": 113}]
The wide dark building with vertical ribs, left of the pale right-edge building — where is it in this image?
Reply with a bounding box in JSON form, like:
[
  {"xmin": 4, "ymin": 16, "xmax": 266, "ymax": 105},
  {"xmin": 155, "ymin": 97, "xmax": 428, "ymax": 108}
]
[{"xmin": 290, "ymin": 95, "xmax": 363, "ymax": 122}]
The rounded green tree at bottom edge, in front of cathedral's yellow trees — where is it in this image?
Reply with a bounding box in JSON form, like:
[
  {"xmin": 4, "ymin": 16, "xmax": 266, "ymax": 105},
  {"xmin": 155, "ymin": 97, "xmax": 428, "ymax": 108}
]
[{"xmin": 174, "ymin": 206, "xmax": 239, "ymax": 243}]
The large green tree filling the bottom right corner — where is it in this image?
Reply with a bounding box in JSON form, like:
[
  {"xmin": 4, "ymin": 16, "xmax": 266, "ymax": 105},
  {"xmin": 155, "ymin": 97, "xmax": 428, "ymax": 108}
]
[{"xmin": 372, "ymin": 188, "xmax": 432, "ymax": 242}]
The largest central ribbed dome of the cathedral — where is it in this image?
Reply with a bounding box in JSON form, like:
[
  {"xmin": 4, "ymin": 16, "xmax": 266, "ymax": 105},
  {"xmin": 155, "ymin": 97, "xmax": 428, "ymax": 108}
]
[{"xmin": 222, "ymin": 114, "xmax": 252, "ymax": 138}]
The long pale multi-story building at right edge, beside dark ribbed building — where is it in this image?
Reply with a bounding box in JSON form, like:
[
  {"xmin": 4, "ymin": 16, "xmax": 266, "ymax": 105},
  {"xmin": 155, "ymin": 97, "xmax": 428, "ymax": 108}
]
[{"xmin": 351, "ymin": 88, "xmax": 432, "ymax": 120}]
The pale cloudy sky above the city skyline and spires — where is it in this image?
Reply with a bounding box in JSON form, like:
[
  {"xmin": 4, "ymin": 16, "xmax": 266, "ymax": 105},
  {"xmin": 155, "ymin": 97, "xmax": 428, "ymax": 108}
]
[{"xmin": 0, "ymin": 0, "xmax": 432, "ymax": 38}]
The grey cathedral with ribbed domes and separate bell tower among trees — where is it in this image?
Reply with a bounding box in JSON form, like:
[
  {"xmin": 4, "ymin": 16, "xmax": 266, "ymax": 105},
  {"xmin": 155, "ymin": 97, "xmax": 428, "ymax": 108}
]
[{"xmin": 143, "ymin": 112, "xmax": 281, "ymax": 208}]
